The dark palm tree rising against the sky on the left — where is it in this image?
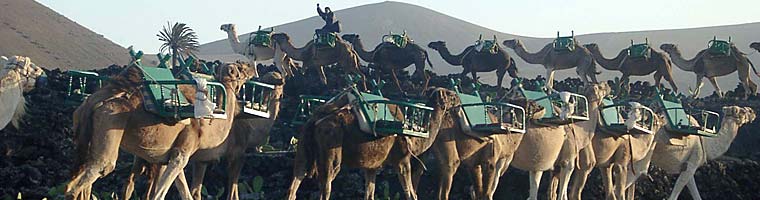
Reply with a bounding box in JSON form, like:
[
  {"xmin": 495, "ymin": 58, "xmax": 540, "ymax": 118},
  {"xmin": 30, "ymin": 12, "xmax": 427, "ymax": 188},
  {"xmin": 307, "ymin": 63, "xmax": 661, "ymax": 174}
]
[{"xmin": 156, "ymin": 22, "xmax": 199, "ymax": 67}]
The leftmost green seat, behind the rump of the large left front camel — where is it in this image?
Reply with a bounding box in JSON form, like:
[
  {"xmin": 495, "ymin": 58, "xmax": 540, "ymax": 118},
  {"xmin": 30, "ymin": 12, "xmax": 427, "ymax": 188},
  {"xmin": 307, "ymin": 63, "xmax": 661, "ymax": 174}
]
[{"xmin": 64, "ymin": 70, "xmax": 108, "ymax": 106}]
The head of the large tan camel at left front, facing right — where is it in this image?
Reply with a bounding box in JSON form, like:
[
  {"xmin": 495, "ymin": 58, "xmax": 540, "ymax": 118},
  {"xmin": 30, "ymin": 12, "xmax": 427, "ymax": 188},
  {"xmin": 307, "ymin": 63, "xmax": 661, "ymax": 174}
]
[{"xmin": 214, "ymin": 62, "xmax": 259, "ymax": 87}]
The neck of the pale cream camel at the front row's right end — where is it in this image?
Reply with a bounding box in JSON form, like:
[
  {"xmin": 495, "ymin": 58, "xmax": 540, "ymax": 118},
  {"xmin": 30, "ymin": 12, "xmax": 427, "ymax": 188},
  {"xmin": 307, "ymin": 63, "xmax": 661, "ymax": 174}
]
[{"xmin": 701, "ymin": 117, "xmax": 740, "ymax": 160}]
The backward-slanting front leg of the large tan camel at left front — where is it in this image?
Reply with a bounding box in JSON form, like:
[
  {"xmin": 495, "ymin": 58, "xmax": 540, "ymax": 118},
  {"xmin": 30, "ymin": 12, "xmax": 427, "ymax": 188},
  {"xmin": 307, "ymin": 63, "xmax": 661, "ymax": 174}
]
[{"xmin": 152, "ymin": 126, "xmax": 198, "ymax": 200}]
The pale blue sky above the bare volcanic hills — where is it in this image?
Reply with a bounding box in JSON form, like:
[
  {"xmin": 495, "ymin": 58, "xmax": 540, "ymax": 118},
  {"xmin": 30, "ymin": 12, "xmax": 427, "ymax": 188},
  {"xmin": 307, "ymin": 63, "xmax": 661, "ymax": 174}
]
[{"xmin": 38, "ymin": 0, "xmax": 760, "ymax": 53}]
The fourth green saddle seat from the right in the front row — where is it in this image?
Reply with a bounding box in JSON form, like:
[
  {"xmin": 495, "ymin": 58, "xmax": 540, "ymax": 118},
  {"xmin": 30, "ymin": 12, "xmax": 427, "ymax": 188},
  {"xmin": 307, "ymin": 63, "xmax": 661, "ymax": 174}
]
[{"xmin": 451, "ymin": 79, "xmax": 525, "ymax": 134}]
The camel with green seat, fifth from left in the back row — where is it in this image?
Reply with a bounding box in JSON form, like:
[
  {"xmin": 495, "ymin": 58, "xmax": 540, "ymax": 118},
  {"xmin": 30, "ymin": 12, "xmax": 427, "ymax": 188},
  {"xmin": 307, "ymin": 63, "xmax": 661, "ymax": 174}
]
[{"xmin": 503, "ymin": 39, "xmax": 599, "ymax": 88}]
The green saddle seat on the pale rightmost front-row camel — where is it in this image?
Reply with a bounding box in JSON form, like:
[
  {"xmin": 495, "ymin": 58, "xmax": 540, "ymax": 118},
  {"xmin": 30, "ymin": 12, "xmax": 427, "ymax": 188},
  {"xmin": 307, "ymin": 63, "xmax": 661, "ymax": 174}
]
[{"xmin": 656, "ymin": 90, "xmax": 720, "ymax": 137}]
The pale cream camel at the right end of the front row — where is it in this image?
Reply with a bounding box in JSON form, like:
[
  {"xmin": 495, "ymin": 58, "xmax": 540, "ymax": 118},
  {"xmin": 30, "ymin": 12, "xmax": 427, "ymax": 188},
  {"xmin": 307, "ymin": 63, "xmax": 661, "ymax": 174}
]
[{"xmin": 652, "ymin": 106, "xmax": 756, "ymax": 200}]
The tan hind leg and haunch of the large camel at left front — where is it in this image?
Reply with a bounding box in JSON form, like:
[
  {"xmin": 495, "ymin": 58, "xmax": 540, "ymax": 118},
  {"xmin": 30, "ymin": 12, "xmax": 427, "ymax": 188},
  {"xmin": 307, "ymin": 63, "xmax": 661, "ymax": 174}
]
[{"xmin": 65, "ymin": 111, "xmax": 127, "ymax": 199}]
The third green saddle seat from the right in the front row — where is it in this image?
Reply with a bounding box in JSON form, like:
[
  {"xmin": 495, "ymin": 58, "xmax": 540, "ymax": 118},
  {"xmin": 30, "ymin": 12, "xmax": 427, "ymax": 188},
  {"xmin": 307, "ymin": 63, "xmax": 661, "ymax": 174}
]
[{"xmin": 512, "ymin": 78, "xmax": 589, "ymax": 125}]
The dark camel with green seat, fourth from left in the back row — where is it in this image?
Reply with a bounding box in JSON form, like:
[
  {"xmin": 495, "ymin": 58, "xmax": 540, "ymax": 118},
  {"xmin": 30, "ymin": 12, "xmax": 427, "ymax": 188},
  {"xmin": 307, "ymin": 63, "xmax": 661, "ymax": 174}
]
[{"xmin": 428, "ymin": 41, "xmax": 517, "ymax": 88}]
